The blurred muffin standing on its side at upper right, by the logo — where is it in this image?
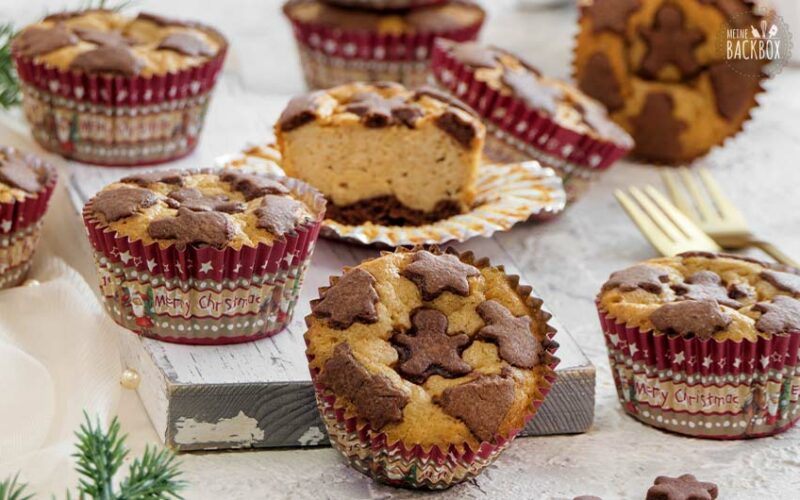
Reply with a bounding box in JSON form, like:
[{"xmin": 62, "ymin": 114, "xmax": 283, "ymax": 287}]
[{"xmin": 574, "ymin": 0, "xmax": 766, "ymax": 164}]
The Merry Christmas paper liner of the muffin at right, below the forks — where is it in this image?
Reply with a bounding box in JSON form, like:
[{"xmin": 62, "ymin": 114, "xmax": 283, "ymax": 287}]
[{"xmin": 598, "ymin": 305, "xmax": 800, "ymax": 439}]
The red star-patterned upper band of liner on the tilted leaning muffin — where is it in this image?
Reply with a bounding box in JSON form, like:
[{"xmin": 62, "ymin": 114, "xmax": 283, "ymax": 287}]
[{"xmin": 431, "ymin": 39, "xmax": 631, "ymax": 171}]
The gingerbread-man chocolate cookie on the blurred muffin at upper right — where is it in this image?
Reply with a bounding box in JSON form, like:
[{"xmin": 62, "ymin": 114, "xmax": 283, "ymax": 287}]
[{"xmin": 639, "ymin": 4, "xmax": 705, "ymax": 78}]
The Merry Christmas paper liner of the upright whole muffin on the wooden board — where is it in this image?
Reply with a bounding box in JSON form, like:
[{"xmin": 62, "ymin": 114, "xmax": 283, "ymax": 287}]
[{"xmin": 83, "ymin": 173, "xmax": 325, "ymax": 344}]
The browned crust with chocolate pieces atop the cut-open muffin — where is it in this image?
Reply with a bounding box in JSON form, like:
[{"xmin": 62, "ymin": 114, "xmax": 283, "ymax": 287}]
[{"xmin": 275, "ymin": 82, "xmax": 486, "ymax": 148}]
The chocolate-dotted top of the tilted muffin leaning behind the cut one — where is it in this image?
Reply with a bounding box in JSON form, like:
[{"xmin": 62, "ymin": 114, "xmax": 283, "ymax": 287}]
[{"xmin": 437, "ymin": 39, "xmax": 631, "ymax": 144}]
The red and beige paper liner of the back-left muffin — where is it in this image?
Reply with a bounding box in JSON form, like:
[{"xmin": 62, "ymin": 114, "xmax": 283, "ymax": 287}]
[{"xmin": 13, "ymin": 27, "xmax": 227, "ymax": 166}]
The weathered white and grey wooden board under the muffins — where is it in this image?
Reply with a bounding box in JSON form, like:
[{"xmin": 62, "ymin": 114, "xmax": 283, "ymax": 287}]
[{"xmin": 70, "ymin": 166, "xmax": 595, "ymax": 451}]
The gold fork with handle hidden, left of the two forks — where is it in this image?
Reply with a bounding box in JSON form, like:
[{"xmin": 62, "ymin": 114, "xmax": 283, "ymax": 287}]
[{"xmin": 614, "ymin": 186, "xmax": 722, "ymax": 257}]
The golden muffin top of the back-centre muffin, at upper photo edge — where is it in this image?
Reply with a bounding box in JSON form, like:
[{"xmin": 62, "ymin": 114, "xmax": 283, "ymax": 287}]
[{"xmin": 284, "ymin": 0, "xmax": 485, "ymax": 35}]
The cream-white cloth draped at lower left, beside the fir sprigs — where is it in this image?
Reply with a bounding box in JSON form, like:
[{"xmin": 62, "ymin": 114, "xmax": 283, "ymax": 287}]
[{"xmin": 0, "ymin": 257, "xmax": 121, "ymax": 497}]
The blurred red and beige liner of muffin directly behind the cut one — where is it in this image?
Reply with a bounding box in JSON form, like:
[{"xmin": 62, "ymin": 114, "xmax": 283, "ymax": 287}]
[{"xmin": 283, "ymin": 0, "xmax": 484, "ymax": 88}]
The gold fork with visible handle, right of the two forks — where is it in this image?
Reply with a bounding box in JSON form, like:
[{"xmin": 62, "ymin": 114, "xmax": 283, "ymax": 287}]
[{"xmin": 663, "ymin": 167, "xmax": 797, "ymax": 267}]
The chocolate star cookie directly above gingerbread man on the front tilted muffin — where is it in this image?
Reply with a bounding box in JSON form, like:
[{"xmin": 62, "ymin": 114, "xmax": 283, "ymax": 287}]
[{"xmin": 400, "ymin": 250, "xmax": 480, "ymax": 301}]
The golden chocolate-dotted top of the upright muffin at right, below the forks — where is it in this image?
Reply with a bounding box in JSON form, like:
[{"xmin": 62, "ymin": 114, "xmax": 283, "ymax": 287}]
[{"xmin": 598, "ymin": 252, "xmax": 800, "ymax": 342}]
